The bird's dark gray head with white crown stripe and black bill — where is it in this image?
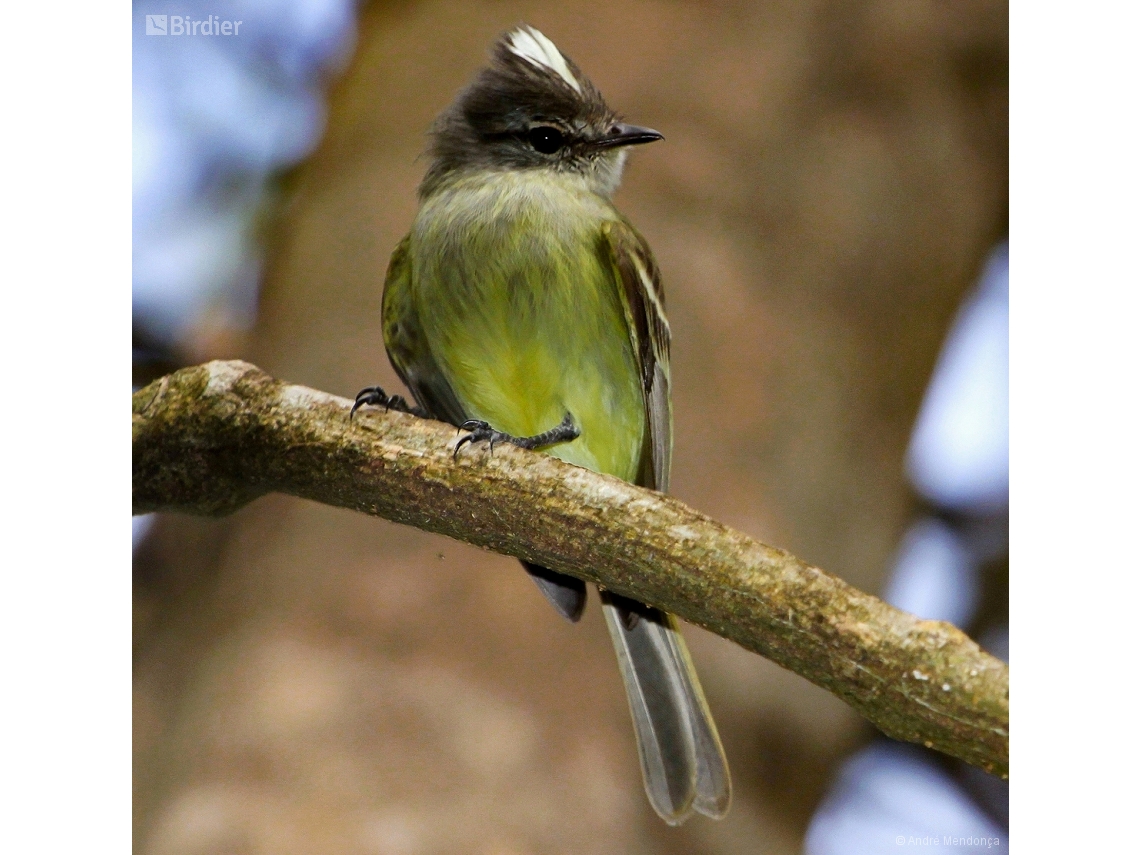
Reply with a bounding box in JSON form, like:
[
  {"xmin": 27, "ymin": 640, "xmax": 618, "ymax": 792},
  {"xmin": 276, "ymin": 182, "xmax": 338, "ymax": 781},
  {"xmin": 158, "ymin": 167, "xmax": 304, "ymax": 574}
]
[{"xmin": 420, "ymin": 26, "xmax": 661, "ymax": 197}]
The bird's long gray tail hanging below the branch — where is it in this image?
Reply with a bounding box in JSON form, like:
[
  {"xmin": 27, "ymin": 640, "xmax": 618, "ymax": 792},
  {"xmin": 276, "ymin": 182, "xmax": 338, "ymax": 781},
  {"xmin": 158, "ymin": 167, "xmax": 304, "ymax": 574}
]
[{"xmin": 602, "ymin": 592, "xmax": 732, "ymax": 825}]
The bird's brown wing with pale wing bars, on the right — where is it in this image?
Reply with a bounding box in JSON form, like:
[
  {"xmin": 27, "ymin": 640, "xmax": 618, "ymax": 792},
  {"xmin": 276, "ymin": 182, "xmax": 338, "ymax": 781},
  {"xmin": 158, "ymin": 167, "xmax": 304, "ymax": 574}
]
[{"xmin": 602, "ymin": 219, "xmax": 673, "ymax": 492}]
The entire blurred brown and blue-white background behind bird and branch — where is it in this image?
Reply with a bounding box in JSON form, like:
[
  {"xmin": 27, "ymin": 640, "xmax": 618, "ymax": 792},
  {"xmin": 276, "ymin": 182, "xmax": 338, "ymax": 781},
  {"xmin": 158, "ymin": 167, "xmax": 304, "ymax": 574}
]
[{"xmin": 132, "ymin": 0, "xmax": 1009, "ymax": 855}]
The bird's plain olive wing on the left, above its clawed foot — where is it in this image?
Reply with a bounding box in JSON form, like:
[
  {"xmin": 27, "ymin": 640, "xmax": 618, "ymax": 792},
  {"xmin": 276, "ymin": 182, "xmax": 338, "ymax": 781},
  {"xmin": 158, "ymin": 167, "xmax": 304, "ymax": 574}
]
[{"xmin": 382, "ymin": 235, "xmax": 466, "ymax": 425}]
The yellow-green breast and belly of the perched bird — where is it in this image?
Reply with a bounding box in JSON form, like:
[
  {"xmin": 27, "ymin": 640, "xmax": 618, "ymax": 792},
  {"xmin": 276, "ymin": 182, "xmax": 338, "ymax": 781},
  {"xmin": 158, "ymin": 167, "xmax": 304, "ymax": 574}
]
[{"xmin": 409, "ymin": 173, "xmax": 645, "ymax": 481}]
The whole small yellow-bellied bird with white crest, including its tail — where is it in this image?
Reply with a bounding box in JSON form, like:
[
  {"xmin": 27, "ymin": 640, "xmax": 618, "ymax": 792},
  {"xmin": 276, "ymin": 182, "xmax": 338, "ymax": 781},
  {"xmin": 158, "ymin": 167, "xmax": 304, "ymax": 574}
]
[{"xmin": 353, "ymin": 26, "xmax": 731, "ymax": 824}]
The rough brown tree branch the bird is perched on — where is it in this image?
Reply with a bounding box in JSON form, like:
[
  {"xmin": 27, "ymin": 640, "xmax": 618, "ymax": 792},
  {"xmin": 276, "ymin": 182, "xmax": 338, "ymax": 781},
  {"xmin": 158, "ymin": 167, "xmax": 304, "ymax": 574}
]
[{"xmin": 133, "ymin": 361, "xmax": 1009, "ymax": 777}]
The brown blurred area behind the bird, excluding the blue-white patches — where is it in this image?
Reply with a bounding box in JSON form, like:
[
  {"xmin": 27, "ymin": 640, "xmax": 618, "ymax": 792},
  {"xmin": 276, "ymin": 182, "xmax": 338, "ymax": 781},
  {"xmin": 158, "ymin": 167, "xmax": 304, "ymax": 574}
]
[{"xmin": 135, "ymin": 0, "xmax": 1008, "ymax": 855}]
